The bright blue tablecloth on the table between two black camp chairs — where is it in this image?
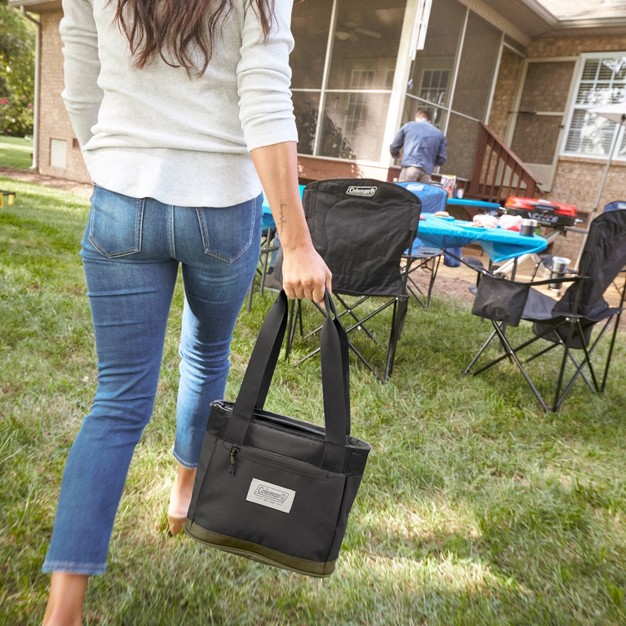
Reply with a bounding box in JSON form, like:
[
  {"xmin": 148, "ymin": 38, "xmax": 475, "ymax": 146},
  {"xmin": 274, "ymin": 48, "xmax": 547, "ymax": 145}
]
[{"xmin": 417, "ymin": 213, "xmax": 548, "ymax": 263}]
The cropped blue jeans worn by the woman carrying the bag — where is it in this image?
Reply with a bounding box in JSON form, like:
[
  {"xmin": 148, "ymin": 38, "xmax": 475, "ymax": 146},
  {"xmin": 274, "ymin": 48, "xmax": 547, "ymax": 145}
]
[{"xmin": 43, "ymin": 187, "xmax": 261, "ymax": 575}]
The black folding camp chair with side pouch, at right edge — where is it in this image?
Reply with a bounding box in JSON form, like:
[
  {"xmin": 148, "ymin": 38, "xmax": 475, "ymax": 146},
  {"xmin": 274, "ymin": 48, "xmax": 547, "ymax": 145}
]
[{"xmin": 465, "ymin": 209, "xmax": 626, "ymax": 411}]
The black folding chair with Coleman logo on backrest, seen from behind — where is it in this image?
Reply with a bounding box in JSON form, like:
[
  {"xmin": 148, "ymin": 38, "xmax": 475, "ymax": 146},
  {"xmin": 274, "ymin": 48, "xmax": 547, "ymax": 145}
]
[{"xmin": 287, "ymin": 179, "xmax": 421, "ymax": 381}]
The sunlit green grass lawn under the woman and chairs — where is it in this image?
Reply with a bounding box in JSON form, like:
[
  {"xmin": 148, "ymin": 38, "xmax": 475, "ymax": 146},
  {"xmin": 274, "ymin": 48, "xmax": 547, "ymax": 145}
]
[{"xmin": 0, "ymin": 178, "xmax": 626, "ymax": 626}]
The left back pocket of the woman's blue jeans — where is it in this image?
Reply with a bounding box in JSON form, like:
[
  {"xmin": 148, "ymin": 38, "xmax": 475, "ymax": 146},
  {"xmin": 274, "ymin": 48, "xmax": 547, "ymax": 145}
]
[{"xmin": 89, "ymin": 186, "xmax": 144, "ymax": 259}]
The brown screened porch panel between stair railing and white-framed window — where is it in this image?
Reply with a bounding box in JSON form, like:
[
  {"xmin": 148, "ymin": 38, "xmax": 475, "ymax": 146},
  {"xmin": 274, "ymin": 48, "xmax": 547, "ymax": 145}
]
[{"xmin": 511, "ymin": 60, "xmax": 575, "ymax": 191}]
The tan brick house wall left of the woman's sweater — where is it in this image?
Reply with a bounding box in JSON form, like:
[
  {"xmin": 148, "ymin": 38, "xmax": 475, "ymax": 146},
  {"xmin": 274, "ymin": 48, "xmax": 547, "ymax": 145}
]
[{"xmin": 39, "ymin": 11, "xmax": 90, "ymax": 182}]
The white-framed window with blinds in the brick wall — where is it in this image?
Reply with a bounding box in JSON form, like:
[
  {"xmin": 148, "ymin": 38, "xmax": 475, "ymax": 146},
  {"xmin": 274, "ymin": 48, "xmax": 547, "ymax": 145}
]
[{"xmin": 564, "ymin": 52, "xmax": 626, "ymax": 159}]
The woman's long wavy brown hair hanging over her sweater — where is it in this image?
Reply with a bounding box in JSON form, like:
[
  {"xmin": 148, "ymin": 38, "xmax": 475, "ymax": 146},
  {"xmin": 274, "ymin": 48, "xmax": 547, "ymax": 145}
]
[{"xmin": 115, "ymin": 0, "xmax": 275, "ymax": 74}]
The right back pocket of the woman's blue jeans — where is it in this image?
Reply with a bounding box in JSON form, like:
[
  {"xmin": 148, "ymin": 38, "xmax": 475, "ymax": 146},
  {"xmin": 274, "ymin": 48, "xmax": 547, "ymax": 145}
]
[{"xmin": 196, "ymin": 198, "xmax": 261, "ymax": 263}]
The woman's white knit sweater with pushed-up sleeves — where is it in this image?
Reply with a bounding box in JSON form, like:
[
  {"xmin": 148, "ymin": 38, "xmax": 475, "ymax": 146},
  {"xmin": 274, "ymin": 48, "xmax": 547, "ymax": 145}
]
[{"xmin": 60, "ymin": 0, "xmax": 297, "ymax": 207}]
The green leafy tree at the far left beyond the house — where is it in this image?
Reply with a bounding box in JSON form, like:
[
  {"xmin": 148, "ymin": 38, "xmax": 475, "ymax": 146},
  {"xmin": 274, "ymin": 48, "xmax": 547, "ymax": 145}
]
[{"xmin": 0, "ymin": 0, "xmax": 35, "ymax": 137}]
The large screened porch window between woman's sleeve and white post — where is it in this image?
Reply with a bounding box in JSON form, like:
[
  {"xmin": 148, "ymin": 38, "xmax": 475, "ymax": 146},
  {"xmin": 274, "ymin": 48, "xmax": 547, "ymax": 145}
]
[{"xmin": 291, "ymin": 0, "xmax": 406, "ymax": 162}]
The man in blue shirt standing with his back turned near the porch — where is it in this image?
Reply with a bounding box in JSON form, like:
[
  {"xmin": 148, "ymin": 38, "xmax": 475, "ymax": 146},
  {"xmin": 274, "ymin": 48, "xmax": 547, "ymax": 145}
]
[{"xmin": 389, "ymin": 110, "xmax": 447, "ymax": 183}]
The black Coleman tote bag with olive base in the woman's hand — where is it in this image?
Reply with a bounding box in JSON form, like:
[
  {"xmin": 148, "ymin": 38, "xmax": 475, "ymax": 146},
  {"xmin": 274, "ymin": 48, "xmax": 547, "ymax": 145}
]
[{"xmin": 185, "ymin": 292, "xmax": 370, "ymax": 577}]
